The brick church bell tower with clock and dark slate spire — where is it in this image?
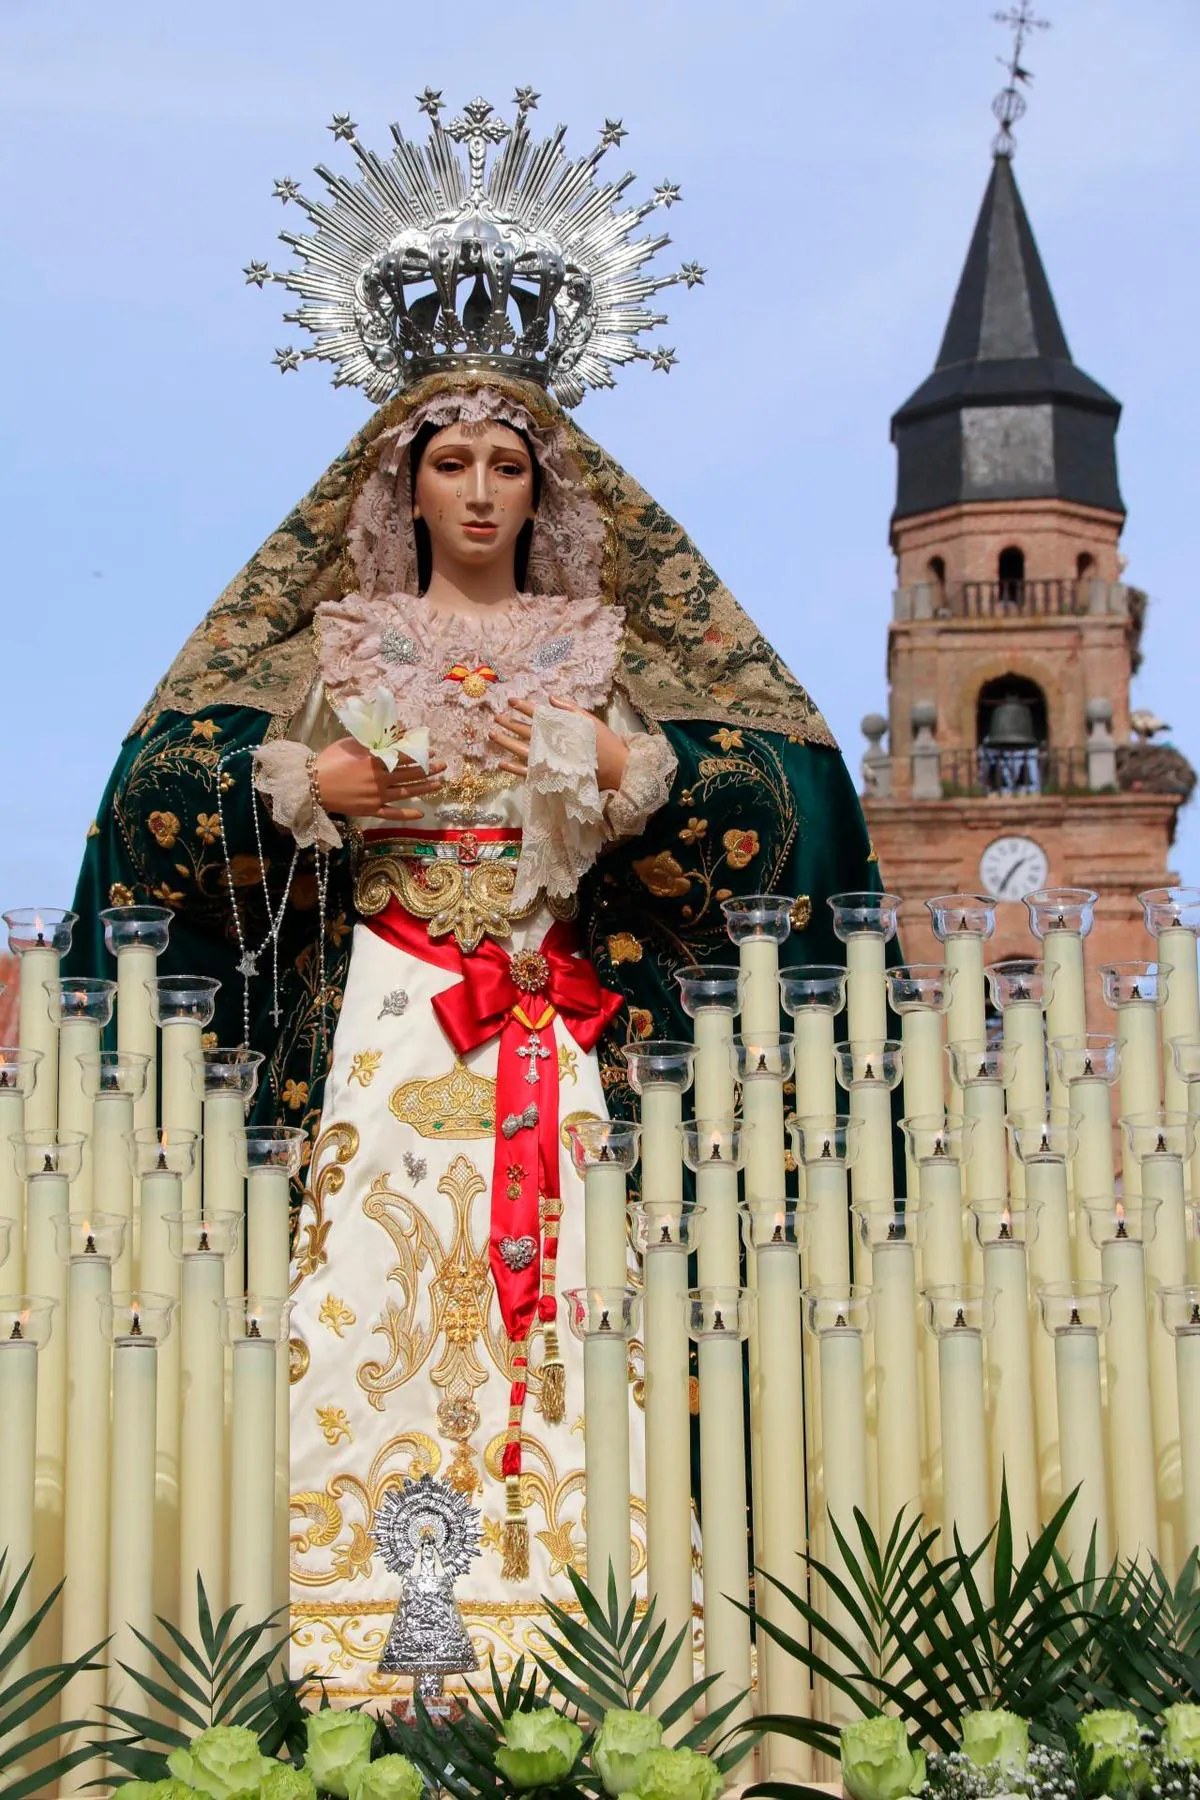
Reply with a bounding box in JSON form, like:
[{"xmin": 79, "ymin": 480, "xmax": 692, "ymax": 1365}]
[{"xmin": 864, "ymin": 131, "xmax": 1195, "ymax": 1000}]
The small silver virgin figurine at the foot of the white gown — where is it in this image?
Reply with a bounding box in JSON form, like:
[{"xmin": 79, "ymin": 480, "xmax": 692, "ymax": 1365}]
[{"xmin": 371, "ymin": 1474, "xmax": 479, "ymax": 1706}]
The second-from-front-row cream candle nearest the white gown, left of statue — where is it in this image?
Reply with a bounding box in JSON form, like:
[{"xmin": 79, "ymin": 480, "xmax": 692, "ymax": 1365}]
[{"xmin": 178, "ymin": 1247, "xmax": 227, "ymax": 1638}]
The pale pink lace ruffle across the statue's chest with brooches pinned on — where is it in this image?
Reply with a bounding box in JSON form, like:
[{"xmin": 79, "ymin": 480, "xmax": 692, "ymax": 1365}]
[{"xmin": 317, "ymin": 594, "xmax": 624, "ymax": 781}]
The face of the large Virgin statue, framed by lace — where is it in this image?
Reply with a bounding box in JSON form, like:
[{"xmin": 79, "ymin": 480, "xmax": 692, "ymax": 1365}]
[{"xmin": 412, "ymin": 425, "xmax": 533, "ymax": 569}]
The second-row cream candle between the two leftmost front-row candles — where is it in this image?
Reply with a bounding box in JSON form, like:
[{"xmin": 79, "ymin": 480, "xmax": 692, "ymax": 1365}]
[{"xmin": 59, "ymin": 1238, "xmax": 112, "ymax": 1730}]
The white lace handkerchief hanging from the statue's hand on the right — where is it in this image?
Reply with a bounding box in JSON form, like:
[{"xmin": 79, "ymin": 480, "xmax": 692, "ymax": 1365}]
[{"xmin": 513, "ymin": 706, "xmax": 606, "ymax": 905}]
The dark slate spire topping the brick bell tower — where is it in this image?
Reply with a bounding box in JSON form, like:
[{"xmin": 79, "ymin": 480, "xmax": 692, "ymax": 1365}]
[{"xmin": 892, "ymin": 155, "xmax": 1124, "ymax": 518}]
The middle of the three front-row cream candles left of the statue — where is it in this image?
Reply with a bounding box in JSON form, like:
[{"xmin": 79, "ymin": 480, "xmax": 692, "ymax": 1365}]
[{"xmin": 106, "ymin": 1337, "xmax": 157, "ymax": 1706}]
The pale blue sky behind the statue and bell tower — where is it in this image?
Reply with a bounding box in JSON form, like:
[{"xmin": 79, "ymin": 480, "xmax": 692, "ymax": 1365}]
[{"xmin": 0, "ymin": 0, "xmax": 1200, "ymax": 905}]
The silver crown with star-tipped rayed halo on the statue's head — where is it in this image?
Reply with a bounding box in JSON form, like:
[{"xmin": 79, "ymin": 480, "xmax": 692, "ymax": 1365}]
[{"xmin": 245, "ymin": 88, "xmax": 705, "ymax": 407}]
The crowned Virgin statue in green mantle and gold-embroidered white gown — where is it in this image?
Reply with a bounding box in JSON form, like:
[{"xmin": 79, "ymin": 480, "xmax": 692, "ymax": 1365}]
[{"xmin": 67, "ymin": 90, "xmax": 876, "ymax": 1699}]
